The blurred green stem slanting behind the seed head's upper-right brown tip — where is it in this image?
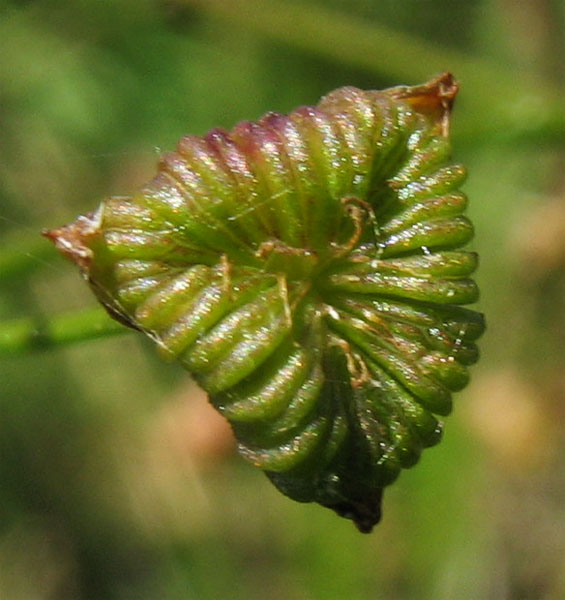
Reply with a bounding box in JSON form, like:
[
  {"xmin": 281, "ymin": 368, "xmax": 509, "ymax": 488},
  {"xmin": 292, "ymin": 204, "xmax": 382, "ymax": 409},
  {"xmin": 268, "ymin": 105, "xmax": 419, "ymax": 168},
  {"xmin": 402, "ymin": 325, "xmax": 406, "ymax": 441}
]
[{"xmin": 183, "ymin": 0, "xmax": 565, "ymax": 143}]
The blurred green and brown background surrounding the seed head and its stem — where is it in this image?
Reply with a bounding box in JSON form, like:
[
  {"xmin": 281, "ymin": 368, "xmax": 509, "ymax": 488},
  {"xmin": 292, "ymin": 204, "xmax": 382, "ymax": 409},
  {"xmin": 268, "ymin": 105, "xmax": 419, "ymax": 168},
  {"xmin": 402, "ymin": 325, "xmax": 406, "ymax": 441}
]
[{"xmin": 0, "ymin": 0, "xmax": 565, "ymax": 600}]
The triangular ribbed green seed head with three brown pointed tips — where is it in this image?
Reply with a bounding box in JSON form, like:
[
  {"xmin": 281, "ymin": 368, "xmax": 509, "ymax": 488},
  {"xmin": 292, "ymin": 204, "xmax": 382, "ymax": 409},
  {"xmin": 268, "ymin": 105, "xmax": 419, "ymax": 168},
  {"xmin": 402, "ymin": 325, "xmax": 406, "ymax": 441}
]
[{"xmin": 47, "ymin": 74, "xmax": 484, "ymax": 532}]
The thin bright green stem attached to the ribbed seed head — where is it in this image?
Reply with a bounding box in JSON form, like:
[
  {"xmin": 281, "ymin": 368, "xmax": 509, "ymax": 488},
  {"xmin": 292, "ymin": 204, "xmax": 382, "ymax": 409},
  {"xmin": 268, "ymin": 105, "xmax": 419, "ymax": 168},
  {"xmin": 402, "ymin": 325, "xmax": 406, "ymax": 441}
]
[{"xmin": 0, "ymin": 308, "xmax": 130, "ymax": 356}]
